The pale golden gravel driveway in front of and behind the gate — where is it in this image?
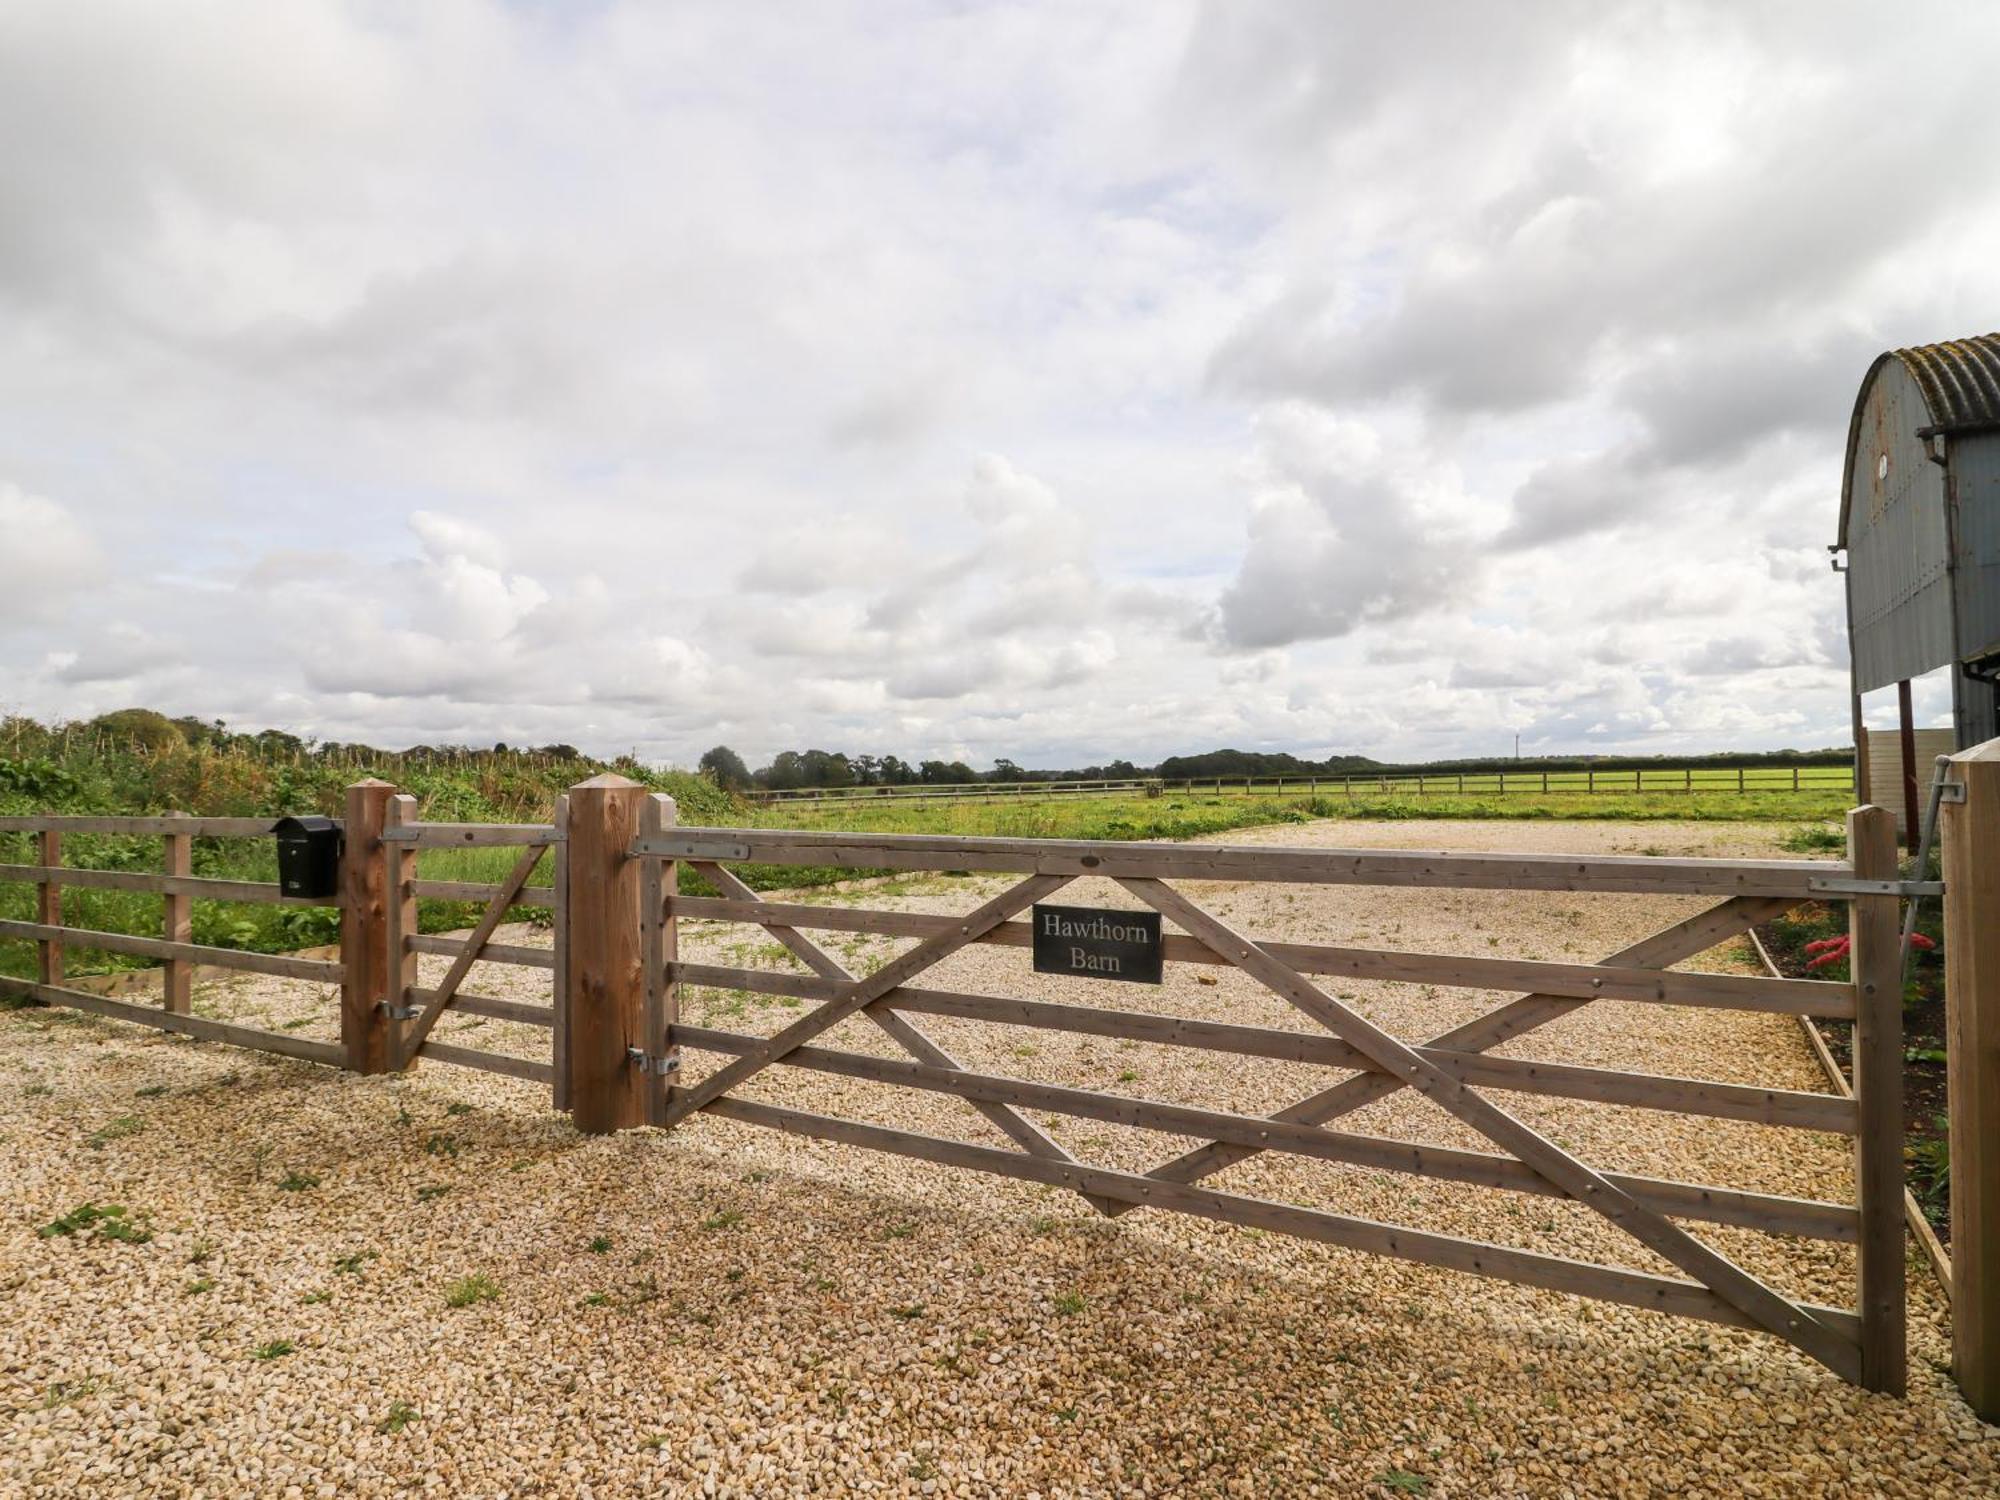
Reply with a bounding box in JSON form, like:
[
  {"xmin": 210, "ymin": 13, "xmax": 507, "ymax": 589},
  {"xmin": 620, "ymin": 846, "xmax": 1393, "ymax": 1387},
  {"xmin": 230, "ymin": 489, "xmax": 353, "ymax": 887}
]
[{"xmin": 0, "ymin": 822, "xmax": 2000, "ymax": 1496}]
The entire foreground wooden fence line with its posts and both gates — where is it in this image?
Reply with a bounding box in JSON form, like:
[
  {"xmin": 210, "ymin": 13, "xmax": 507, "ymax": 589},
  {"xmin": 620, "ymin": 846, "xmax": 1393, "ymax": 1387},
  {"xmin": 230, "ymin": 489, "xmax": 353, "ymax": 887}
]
[{"xmin": 11, "ymin": 776, "xmax": 2000, "ymax": 1392}]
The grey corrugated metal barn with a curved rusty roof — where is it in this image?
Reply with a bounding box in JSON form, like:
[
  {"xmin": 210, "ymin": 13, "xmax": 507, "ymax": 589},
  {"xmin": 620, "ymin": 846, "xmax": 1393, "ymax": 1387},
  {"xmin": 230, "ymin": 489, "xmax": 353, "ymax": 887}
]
[{"xmin": 1832, "ymin": 334, "xmax": 2000, "ymax": 812}]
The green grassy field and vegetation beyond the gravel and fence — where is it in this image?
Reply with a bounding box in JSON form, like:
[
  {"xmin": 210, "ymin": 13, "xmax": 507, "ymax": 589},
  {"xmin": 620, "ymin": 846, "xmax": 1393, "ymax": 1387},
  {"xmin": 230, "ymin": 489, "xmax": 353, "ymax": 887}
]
[{"xmin": 0, "ymin": 744, "xmax": 1850, "ymax": 992}]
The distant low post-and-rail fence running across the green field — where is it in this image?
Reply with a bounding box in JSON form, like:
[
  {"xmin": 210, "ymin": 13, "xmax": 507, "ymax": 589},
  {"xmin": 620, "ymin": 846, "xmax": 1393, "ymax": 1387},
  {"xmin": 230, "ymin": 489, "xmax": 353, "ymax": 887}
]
[{"xmin": 744, "ymin": 766, "xmax": 1854, "ymax": 806}]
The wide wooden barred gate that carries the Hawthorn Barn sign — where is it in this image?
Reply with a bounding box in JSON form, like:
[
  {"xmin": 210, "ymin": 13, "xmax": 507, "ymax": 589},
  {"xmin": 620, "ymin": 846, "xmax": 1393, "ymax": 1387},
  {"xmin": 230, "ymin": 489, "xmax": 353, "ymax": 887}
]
[{"xmin": 608, "ymin": 804, "xmax": 1904, "ymax": 1392}]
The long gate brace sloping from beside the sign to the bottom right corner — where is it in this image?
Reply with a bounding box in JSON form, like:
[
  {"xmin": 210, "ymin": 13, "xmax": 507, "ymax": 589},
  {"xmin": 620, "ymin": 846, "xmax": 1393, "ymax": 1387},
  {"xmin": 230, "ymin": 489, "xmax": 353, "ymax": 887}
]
[{"xmin": 1118, "ymin": 876, "xmax": 1860, "ymax": 1378}]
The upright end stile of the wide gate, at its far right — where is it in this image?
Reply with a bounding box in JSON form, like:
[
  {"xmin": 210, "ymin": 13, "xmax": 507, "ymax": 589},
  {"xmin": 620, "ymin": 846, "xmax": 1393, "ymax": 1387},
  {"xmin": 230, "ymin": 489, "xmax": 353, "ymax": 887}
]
[{"xmin": 1848, "ymin": 806, "xmax": 1906, "ymax": 1396}]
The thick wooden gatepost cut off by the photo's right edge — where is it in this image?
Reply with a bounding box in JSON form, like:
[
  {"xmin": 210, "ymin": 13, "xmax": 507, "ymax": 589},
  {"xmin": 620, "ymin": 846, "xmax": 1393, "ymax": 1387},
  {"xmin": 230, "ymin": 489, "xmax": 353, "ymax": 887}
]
[{"xmin": 1940, "ymin": 740, "xmax": 2000, "ymax": 1422}]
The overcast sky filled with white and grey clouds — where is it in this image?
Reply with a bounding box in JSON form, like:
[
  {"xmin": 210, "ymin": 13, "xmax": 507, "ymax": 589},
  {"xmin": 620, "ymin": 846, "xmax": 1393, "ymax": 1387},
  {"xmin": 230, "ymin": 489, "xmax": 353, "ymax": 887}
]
[{"xmin": 0, "ymin": 0, "xmax": 2000, "ymax": 766}]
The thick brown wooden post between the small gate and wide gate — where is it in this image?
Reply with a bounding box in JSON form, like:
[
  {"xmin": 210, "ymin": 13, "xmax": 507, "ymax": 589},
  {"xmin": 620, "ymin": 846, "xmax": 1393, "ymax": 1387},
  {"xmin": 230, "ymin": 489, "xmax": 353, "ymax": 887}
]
[{"xmin": 566, "ymin": 772, "xmax": 648, "ymax": 1136}]
